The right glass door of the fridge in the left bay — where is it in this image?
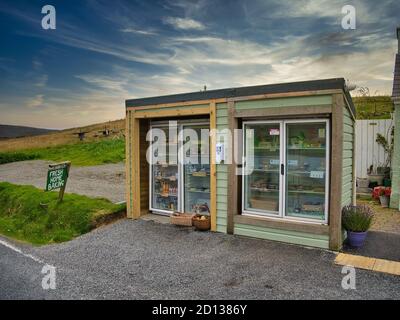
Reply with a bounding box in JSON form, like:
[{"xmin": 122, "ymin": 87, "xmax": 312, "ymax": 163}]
[{"xmin": 182, "ymin": 124, "xmax": 210, "ymax": 215}]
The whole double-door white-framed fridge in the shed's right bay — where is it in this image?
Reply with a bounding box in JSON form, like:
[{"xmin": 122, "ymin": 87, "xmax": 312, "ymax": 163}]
[{"xmin": 242, "ymin": 119, "xmax": 330, "ymax": 223}]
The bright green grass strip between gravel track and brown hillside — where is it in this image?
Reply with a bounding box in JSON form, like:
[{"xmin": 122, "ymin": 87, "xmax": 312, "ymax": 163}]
[{"xmin": 0, "ymin": 139, "xmax": 125, "ymax": 166}]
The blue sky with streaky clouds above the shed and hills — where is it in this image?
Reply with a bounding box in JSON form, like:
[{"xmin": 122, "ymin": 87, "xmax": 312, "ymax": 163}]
[{"xmin": 0, "ymin": 0, "xmax": 400, "ymax": 128}]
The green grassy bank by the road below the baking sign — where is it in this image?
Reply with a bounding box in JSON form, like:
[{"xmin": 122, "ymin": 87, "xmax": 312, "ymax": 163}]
[{"xmin": 0, "ymin": 182, "xmax": 125, "ymax": 244}]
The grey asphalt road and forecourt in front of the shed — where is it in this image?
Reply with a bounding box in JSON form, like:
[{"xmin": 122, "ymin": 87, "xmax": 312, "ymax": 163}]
[{"xmin": 0, "ymin": 219, "xmax": 400, "ymax": 299}]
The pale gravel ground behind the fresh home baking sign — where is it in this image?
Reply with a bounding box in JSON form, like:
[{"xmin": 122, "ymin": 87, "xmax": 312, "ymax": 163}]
[{"xmin": 0, "ymin": 160, "xmax": 125, "ymax": 202}]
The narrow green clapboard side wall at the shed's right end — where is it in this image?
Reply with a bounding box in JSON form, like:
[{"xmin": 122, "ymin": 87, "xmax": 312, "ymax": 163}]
[{"xmin": 341, "ymin": 108, "xmax": 354, "ymax": 206}]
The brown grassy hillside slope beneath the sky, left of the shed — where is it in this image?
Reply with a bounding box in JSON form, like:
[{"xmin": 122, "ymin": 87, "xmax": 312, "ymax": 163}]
[{"xmin": 0, "ymin": 119, "xmax": 125, "ymax": 152}]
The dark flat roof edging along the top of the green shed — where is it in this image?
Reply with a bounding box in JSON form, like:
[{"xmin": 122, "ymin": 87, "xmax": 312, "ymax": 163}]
[{"xmin": 125, "ymin": 78, "xmax": 355, "ymax": 114}]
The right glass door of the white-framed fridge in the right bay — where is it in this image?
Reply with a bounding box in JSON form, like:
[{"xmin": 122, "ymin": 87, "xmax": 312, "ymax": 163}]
[{"xmin": 285, "ymin": 120, "xmax": 330, "ymax": 221}]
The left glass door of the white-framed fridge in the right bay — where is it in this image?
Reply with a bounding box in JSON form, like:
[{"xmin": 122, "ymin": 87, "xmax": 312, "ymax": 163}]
[{"xmin": 243, "ymin": 122, "xmax": 282, "ymax": 216}]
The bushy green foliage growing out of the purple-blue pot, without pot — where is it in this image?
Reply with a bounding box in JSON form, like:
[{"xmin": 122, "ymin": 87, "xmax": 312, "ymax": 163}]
[{"xmin": 342, "ymin": 205, "xmax": 374, "ymax": 232}]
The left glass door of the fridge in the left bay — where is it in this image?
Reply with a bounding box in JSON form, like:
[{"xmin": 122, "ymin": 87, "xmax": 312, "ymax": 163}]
[{"xmin": 150, "ymin": 126, "xmax": 179, "ymax": 215}]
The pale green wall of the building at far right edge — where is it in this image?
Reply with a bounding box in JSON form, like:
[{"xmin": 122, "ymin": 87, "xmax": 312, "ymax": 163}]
[{"xmin": 390, "ymin": 102, "xmax": 400, "ymax": 210}]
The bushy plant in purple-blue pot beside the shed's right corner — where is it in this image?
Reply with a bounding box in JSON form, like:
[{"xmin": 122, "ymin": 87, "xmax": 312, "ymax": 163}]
[{"xmin": 342, "ymin": 205, "xmax": 374, "ymax": 248}]
